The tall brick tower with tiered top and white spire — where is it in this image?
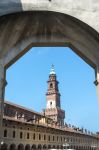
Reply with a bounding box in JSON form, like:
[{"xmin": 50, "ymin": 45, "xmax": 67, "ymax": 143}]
[{"xmin": 45, "ymin": 65, "xmax": 65, "ymax": 125}]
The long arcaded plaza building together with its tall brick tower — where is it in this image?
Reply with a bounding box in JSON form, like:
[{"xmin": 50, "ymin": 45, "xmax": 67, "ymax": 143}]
[{"xmin": 1, "ymin": 67, "xmax": 99, "ymax": 150}]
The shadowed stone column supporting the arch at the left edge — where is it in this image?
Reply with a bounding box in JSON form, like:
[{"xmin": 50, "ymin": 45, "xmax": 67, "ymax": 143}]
[{"xmin": 0, "ymin": 60, "xmax": 5, "ymax": 146}]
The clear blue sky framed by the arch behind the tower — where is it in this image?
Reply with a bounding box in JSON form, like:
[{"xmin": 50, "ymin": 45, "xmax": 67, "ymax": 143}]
[{"xmin": 5, "ymin": 47, "xmax": 99, "ymax": 132}]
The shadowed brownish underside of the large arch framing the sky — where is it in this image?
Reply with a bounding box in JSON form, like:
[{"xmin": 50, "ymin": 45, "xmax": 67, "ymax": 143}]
[{"xmin": 0, "ymin": 11, "xmax": 99, "ymax": 68}]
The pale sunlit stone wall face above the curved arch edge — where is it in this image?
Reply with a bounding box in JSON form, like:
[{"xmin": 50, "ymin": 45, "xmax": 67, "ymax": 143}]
[{"xmin": 0, "ymin": 0, "xmax": 99, "ymax": 31}]
